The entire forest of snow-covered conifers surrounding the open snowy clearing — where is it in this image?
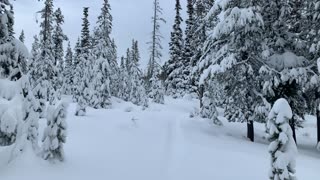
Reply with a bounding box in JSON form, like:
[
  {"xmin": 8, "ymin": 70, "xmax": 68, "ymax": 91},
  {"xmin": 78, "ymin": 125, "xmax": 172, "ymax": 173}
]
[{"xmin": 0, "ymin": 0, "xmax": 320, "ymax": 180}]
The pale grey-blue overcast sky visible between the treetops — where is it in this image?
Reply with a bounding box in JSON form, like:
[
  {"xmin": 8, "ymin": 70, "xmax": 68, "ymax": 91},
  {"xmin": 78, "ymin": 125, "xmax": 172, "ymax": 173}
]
[{"xmin": 14, "ymin": 0, "xmax": 187, "ymax": 66}]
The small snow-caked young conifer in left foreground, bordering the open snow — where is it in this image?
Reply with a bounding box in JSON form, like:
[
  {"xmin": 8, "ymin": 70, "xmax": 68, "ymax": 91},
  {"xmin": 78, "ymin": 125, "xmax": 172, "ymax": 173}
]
[{"xmin": 42, "ymin": 102, "xmax": 68, "ymax": 161}]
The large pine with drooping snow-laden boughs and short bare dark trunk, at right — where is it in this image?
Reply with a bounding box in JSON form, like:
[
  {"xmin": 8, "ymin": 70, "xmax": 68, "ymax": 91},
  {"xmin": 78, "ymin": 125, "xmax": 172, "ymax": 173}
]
[{"xmin": 199, "ymin": 0, "xmax": 264, "ymax": 141}]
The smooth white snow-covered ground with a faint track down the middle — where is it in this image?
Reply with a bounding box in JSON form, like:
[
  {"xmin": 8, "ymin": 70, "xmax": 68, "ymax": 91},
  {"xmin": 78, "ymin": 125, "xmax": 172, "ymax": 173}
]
[{"xmin": 0, "ymin": 99, "xmax": 320, "ymax": 180}]
